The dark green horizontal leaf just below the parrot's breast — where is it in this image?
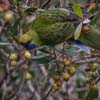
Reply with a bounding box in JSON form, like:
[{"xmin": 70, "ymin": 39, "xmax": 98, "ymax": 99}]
[{"xmin": 32, "ymin": 54, "xmax": 54, "ymax": 64}]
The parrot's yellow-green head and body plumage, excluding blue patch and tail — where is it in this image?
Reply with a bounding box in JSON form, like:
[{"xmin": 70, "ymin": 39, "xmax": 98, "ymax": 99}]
[{"xmin": 20, "ymin": 9, "xmax": 74, "ymax": 46}]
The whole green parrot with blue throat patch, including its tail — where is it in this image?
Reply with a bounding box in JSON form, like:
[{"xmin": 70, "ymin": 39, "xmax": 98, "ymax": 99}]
[{"xmin": 19, "ymin": 8, "xmax": 100, "ymax": 50}]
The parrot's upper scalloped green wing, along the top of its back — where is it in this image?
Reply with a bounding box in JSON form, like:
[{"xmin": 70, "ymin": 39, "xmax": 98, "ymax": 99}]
[{"xmin": 32, "ymin": 8, "xmax": 70, "ymax": 28}]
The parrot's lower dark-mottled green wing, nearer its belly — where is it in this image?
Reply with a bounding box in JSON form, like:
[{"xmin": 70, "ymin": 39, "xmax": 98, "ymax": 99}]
[{"xmin": 38, "ymin": 22, "xmax": 74, "ymax": 45}]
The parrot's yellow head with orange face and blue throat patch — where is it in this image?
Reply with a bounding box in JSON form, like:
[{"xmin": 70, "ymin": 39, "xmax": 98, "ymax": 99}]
[{"xmin": 19, "ymin": 30, "xmax": 40, "ymax": 50}]
